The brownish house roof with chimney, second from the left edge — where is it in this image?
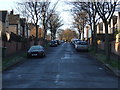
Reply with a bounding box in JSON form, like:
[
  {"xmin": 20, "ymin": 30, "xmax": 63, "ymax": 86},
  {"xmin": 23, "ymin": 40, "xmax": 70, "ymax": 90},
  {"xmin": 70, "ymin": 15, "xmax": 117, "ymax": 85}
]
[{"xmin": 8, "ymin": 14, "xmax": 20, "ymax": 24}]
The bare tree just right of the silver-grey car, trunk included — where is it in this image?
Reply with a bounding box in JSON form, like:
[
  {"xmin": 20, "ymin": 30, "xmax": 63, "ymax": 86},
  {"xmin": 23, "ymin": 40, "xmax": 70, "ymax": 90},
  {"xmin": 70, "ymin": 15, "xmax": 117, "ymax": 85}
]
[{"xmin": 73, "ymin": 0, "xmax": 100, "ymax": 53}]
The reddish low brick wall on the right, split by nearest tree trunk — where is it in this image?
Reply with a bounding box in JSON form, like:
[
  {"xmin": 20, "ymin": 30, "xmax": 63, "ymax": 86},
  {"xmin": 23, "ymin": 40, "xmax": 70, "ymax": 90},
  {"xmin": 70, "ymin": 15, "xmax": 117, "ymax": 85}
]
[{"xmin": 98, "ymin": 41, "xmax": 120, "ymax": 56}]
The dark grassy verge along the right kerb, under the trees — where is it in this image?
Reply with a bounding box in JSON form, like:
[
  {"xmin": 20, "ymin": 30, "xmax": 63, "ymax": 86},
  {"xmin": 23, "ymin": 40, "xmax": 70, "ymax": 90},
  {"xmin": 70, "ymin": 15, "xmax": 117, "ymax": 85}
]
[{"xmin": 90, "ymin": 49, "xmax": 120, "ymax": 77}]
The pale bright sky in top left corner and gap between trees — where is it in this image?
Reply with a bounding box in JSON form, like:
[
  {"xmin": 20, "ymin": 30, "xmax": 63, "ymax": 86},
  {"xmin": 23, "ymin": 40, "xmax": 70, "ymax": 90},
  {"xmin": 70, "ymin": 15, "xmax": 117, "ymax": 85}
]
[{"xmin": 0, "ymin": 0, "xmax": 72, "ymax": 29}]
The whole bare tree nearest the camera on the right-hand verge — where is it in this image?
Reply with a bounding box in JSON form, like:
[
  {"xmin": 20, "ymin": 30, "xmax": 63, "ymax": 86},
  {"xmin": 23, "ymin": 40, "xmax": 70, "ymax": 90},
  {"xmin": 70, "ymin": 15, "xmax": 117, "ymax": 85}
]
[{"xmin": 95, "ymin": 0, "xmax": 117, "ymax": 60}]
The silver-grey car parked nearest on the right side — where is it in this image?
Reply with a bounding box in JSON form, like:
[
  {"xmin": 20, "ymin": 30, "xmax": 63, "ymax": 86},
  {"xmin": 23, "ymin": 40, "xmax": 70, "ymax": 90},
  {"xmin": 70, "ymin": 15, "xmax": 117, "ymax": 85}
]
[{"xmin": 75, "ymin": 41, "xmax": 89, "ymax": 51}]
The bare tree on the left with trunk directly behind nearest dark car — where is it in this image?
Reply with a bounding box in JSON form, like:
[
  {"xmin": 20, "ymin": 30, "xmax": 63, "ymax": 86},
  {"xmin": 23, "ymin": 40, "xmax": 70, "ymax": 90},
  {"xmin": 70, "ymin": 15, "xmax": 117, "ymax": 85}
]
[{"xmin": 17, "ymin": 0, "xmax": 49, "ymax": 44}]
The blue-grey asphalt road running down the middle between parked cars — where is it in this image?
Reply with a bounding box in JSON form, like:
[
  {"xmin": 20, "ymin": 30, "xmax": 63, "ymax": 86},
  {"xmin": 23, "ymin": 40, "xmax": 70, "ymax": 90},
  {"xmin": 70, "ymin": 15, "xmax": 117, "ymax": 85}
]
[{"xmin": 3, "ymin": 43, "xmax": 119, "ymax": 88}]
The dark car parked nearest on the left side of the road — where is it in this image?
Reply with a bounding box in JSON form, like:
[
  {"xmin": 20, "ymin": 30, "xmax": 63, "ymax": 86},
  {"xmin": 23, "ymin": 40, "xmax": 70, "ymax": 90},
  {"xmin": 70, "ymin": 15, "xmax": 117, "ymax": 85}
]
[{"xmin": 27, "ymin": 45, "xmax": 45, "ymax": 57}]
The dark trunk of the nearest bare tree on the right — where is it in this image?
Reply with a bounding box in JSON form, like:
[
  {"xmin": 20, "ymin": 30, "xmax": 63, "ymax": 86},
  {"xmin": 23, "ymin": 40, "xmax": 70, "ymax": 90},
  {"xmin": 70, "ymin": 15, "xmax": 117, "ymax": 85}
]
[{"xmin": 104, "ymin": 20, "xmax": 110, "ymax": 61}]
